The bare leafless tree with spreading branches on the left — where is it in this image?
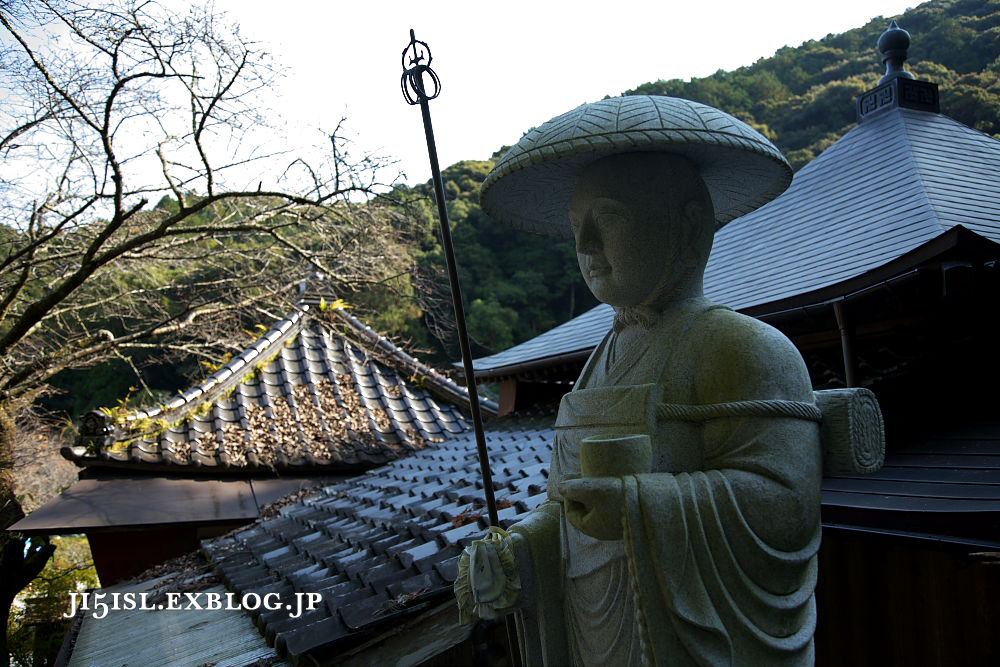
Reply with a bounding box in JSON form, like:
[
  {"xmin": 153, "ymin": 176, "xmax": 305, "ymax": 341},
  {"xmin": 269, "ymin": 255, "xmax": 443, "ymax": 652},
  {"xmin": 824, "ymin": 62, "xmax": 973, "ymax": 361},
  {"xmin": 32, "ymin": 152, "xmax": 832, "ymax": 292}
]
[{"xmin": 0, "ymin": 0, "xmax": 420, "ymax": 664}]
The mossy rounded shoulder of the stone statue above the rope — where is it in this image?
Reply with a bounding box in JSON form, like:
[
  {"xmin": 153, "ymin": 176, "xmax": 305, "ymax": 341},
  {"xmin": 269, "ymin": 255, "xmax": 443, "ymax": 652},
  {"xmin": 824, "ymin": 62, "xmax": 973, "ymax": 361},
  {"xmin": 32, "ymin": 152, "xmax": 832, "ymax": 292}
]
[{"xmin": 687, "ymin": 308, "xmax": 812, "ymax": 403}]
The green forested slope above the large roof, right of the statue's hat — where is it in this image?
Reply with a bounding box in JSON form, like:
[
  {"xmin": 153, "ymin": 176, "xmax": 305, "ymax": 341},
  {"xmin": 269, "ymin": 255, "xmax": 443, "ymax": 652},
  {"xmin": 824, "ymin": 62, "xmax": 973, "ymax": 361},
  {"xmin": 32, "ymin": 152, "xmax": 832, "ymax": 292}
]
[{"xmin": 624, "ymin": 0, "xmax": 1000, "ymax": 169}]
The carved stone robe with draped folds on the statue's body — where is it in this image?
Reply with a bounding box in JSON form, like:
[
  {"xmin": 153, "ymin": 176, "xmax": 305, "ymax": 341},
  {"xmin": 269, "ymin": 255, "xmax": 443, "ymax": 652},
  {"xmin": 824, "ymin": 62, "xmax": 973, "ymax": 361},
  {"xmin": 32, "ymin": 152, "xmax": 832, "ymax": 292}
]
[{"xmin": 511, "ymin": 299, "xmax": 821, "ymax": 665}]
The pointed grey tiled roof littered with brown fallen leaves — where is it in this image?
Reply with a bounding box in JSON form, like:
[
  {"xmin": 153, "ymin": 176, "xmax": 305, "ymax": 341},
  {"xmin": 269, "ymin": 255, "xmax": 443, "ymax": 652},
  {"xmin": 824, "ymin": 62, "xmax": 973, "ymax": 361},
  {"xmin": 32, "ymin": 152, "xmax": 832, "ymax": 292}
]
[{"xmin": 64, "ymin": 304, "xmax": 493, "ymax": 471}]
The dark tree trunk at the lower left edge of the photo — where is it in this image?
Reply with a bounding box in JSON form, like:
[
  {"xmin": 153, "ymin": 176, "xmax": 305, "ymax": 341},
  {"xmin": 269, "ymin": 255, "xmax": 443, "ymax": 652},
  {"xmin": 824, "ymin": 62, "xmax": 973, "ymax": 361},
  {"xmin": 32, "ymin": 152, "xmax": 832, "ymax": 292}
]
[{"xmin": 0, "ymin": 405, "xmax": 55, "ymax": 667}]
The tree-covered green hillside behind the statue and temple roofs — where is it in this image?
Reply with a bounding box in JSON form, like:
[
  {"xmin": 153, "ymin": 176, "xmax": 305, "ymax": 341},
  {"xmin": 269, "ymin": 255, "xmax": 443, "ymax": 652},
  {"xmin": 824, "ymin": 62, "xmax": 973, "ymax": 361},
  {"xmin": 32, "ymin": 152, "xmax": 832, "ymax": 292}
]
[{"xmin": 37, "ymin": 0, "xmax": 1000, "ymax": 409}]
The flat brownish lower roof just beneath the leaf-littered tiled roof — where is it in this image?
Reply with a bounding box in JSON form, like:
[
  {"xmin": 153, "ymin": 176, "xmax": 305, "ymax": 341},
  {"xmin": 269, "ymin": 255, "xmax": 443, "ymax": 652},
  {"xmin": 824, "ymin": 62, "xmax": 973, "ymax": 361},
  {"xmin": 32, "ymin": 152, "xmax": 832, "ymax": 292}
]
[{"xmin": 11, "ymin": 474, "xmax": 330, "ymax": 534}]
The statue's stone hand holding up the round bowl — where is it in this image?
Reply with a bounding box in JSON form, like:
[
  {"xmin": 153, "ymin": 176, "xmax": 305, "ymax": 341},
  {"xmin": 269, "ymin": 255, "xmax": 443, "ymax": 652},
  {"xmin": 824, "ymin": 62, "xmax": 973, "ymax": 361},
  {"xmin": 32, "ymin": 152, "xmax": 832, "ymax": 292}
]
[{"xmin": 559, "ymin": 477, "xmax": 625, "ymax": 540}]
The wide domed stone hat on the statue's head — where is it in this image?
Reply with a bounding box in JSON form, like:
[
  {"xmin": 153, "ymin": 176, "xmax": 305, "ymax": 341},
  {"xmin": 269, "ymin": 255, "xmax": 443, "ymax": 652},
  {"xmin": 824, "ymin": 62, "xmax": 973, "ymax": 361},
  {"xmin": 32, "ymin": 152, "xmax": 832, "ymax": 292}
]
[{"xmin": 480, "ymin": 95, "xmax": 792, "ymax": 236}]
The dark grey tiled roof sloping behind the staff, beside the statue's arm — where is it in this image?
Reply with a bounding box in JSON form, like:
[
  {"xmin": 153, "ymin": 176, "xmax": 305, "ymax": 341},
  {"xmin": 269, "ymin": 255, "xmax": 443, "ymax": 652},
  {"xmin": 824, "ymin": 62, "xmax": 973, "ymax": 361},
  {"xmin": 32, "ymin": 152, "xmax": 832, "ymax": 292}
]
[{"xmin": 198, "ymin": 419, "xmax": 552, "ymax": 662}]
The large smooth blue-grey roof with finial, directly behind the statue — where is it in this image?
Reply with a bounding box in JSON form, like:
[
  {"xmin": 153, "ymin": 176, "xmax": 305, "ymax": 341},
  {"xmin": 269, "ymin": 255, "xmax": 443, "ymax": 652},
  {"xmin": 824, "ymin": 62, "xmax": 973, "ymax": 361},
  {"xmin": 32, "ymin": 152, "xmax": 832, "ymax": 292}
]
[{"xmin": 474, "ymin": 108, "xmax": 1000, "ymax": 376}]
